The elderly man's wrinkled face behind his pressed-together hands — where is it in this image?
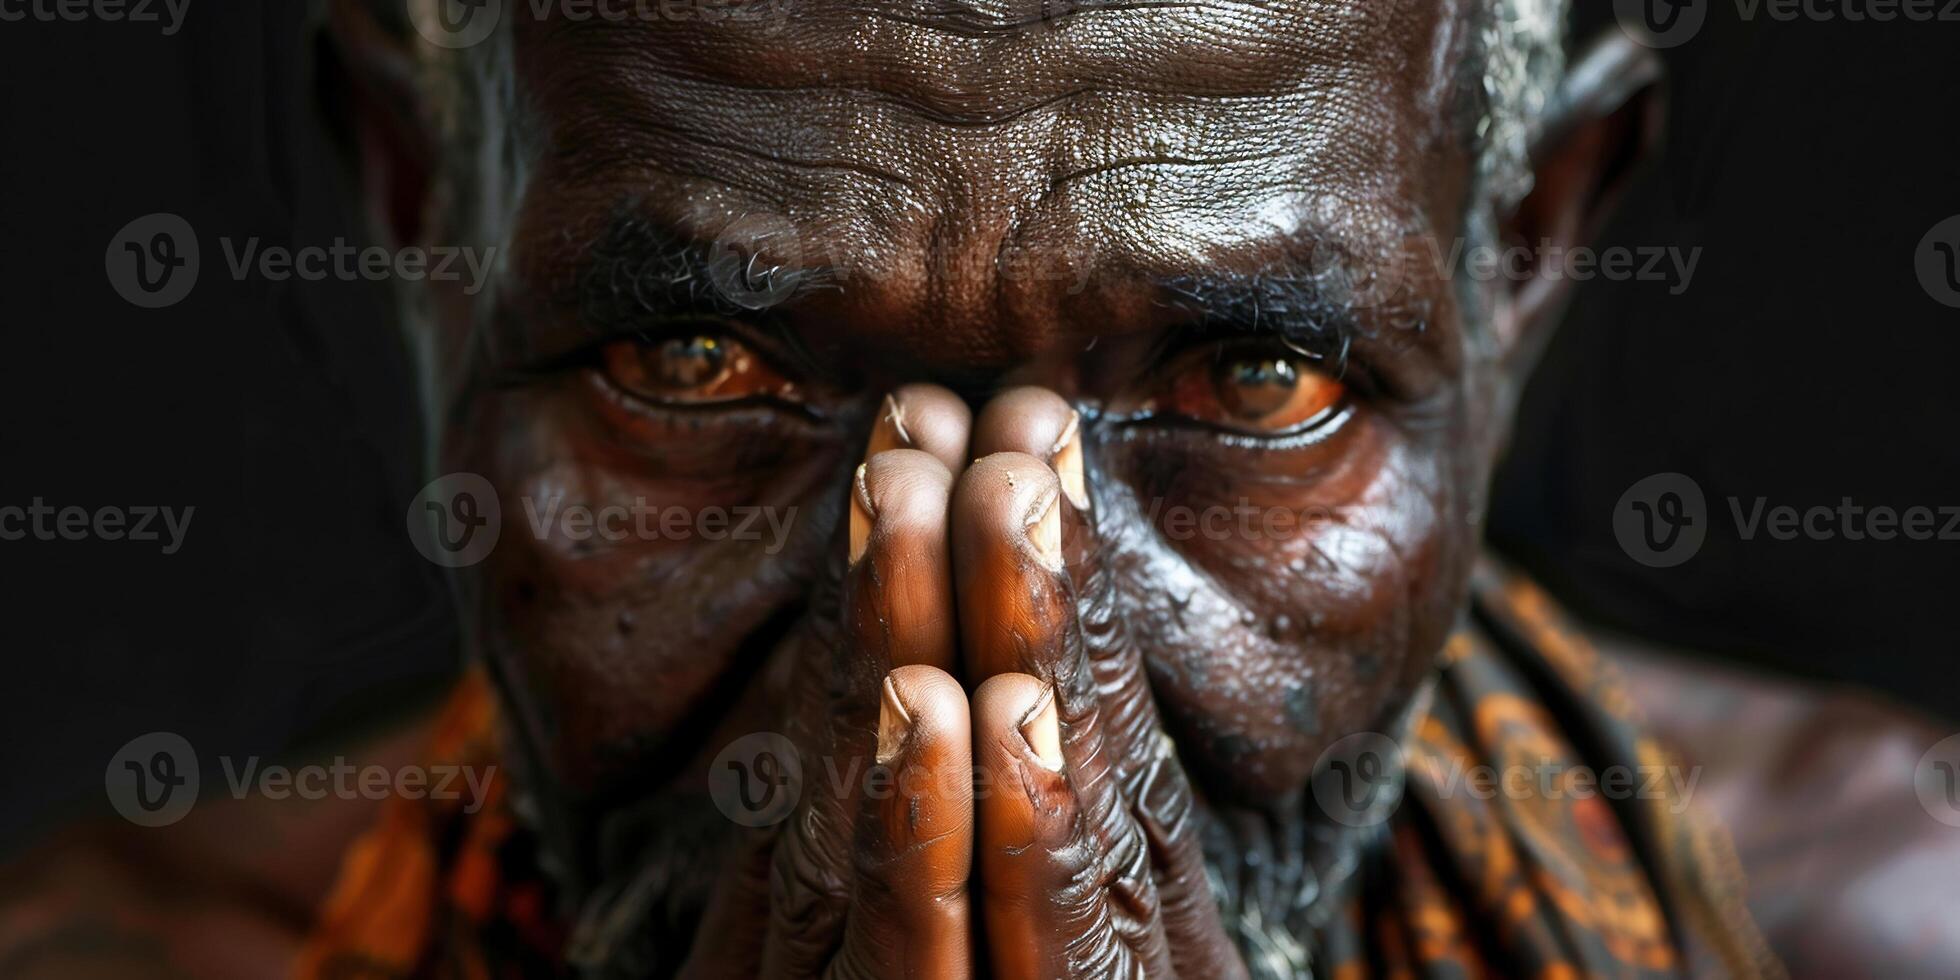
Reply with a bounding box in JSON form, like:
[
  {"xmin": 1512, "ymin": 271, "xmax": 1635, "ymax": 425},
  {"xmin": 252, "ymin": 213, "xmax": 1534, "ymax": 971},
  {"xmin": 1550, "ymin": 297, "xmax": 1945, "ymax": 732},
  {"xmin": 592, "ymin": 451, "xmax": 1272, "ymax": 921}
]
[{"xmin": 445, "ymin": 0, "xmax": 1494, "ymax": 811}]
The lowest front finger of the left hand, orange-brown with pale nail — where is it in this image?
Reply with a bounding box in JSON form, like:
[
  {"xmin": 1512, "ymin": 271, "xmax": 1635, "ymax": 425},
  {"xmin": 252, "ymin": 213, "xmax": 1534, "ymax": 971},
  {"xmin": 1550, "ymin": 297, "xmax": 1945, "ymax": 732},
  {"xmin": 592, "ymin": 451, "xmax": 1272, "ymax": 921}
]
[{"xmin": 831, "ymin": 666, "xmax": 974, "ymax": 980}]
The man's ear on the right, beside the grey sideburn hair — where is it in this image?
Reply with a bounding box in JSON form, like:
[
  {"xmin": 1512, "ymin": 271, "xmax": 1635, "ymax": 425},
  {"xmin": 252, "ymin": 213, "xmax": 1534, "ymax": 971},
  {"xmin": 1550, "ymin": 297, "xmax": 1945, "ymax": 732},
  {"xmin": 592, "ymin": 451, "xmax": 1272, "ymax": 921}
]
[{"xmin": 1495, "ymin": 29, "xmax": 1664, "ymax": 382}]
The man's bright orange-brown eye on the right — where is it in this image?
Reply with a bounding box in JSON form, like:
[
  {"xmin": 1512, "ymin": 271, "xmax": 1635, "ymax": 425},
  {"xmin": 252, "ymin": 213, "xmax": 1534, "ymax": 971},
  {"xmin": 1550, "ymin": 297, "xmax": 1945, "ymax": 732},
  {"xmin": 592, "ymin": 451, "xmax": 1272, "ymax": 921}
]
[{"xmin": 1156, "ymin": 347, "xmax": 1347, "ymax": 435}]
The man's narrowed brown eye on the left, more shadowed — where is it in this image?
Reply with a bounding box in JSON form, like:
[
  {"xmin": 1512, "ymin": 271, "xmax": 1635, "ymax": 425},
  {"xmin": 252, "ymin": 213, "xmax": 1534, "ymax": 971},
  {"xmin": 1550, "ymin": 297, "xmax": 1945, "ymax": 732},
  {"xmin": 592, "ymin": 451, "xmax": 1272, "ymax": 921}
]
[{"xmin": 604, "ymin": 333, "xmax": 794, "ymax": 404}]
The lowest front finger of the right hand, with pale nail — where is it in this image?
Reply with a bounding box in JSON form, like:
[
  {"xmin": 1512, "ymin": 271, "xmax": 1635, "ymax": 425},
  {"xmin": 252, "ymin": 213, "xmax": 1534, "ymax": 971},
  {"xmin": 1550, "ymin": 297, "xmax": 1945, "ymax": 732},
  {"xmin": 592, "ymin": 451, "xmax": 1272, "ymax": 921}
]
[{"xmin": 972, "ymin": 674, "xmax": 1170, "ymax": 980}]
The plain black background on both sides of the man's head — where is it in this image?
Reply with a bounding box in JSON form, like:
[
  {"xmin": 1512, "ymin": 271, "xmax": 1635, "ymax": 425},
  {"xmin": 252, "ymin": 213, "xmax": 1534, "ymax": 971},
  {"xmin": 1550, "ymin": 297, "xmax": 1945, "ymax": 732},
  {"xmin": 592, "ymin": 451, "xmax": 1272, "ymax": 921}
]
[{"xmin": 0, "ymin": 0, "xmax": 1960, "ymax": 849}]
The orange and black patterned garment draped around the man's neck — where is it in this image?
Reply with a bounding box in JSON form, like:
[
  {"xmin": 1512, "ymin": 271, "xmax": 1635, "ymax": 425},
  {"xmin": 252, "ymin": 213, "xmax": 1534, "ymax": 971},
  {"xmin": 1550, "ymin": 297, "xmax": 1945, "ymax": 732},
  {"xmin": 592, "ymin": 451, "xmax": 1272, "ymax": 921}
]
[{"xmin": 296, "ymin": 570, "xmax": 1782, "ymax": 980}]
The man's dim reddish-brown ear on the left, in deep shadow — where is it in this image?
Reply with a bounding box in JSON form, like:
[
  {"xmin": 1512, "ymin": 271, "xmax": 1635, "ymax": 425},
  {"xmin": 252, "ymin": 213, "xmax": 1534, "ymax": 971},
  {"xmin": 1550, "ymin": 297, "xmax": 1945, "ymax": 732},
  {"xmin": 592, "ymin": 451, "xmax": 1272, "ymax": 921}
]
[{"xmin": 319, "ymin": 0, "xmax": 435, "ymax": 245}]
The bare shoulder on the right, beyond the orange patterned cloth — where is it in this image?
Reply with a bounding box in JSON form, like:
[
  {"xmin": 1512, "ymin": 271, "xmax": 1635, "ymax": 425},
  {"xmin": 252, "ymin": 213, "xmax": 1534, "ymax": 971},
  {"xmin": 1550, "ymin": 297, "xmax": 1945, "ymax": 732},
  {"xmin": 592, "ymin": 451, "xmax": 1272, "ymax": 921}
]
[{"xmin": 1601, "ymin": 641, "xmax": 1960, "ymax": 978}]
